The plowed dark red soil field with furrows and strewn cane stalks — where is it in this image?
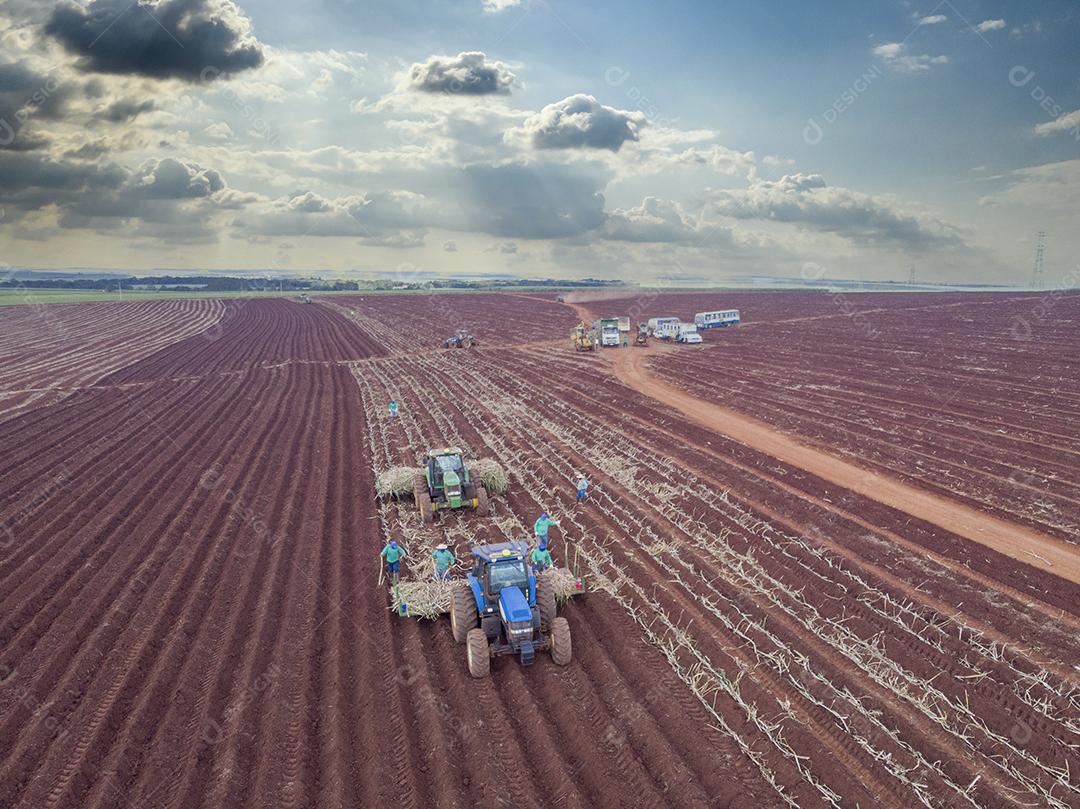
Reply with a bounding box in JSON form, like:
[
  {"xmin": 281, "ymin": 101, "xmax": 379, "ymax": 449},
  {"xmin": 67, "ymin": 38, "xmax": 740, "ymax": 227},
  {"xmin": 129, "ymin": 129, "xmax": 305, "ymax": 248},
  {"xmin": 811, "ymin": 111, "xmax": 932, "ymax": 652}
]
[{"xmin": 0, "ymin": 293, "xmax": 1080, "ymax": 809}]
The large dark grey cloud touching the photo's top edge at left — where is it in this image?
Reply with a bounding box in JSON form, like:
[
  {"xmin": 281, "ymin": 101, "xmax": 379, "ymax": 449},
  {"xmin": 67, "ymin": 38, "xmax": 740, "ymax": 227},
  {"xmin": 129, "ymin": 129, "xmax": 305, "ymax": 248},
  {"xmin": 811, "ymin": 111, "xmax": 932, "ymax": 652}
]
[{"xmin": 45, "ymin": 0, "xmax": 264, "ymax": 81}]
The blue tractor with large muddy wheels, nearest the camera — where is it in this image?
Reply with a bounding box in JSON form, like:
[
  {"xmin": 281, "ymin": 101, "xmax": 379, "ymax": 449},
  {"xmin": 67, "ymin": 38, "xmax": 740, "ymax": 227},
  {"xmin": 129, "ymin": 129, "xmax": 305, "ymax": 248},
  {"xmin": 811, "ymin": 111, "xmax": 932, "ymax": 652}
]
[{"xmin": 450, "ymin": 542, "xmax": 571, "ymax": 677}]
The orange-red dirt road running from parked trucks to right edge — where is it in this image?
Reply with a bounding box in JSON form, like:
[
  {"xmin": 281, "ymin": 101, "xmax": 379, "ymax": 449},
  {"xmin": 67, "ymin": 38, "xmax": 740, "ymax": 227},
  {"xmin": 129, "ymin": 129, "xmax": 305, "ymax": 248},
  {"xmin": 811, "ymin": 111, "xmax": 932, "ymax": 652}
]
[{"xmin": 612, "ymin": 343, "xmax": 1080, "ymax": 583}]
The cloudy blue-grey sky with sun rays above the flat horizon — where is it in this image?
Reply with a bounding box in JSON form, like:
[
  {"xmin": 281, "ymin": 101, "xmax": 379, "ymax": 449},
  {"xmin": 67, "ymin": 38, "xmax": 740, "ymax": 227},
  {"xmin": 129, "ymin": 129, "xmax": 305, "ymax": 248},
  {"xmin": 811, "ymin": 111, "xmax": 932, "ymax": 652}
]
[{"xmin": 0, "ymin": 0, "xmax": 1080, "ymax": 283}]
